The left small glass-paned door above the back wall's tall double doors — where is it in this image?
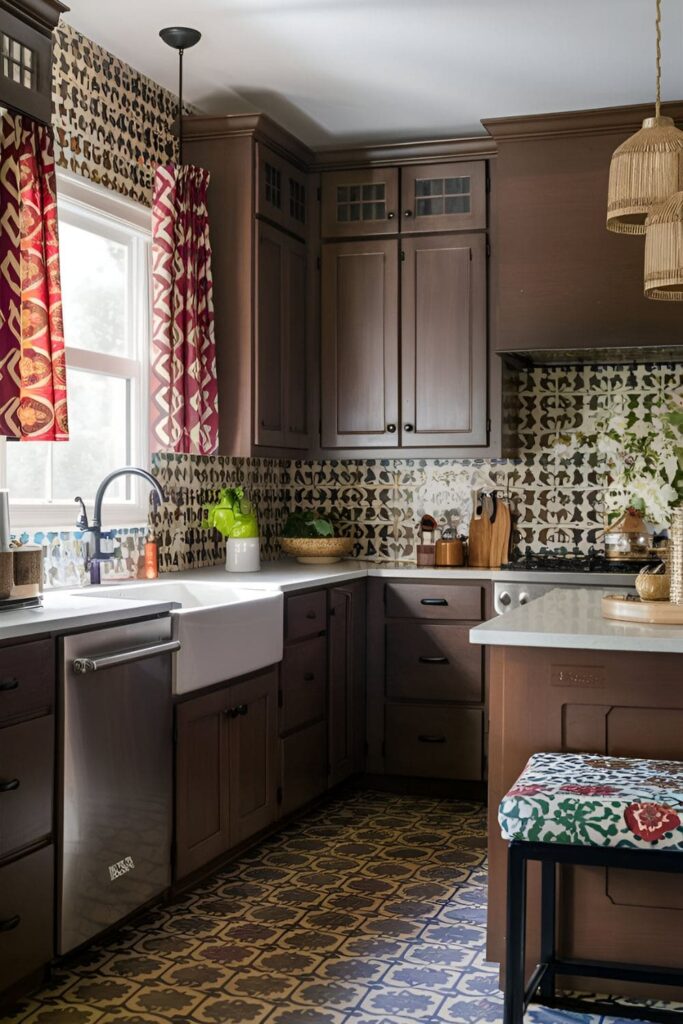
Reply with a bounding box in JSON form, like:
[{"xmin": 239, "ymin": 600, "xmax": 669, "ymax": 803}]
[{"xmin": 321, "ymin": 167, "xmax": 400, "ymax": 239}]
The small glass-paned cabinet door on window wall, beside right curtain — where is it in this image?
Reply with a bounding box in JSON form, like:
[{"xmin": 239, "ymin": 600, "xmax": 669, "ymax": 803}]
[{"xmin": 256, "ymin": 142, "xmax": 308, "ymax": 239}]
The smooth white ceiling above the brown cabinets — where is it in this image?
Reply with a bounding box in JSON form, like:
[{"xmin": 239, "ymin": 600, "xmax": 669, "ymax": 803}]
[{"xmin": 66, "ymin": 0, "xmax": 683, "ymax": 146}]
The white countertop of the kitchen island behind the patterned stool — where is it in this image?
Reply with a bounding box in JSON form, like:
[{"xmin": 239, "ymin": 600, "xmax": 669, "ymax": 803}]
[{"xmin": 470, "ymin": 587, "xmax": 683, "ymax": 654}]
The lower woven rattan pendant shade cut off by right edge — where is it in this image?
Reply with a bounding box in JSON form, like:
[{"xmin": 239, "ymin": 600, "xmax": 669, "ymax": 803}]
[{"xmin": 645, "ymin": 191, "xmax": 683, "ymax": 302}]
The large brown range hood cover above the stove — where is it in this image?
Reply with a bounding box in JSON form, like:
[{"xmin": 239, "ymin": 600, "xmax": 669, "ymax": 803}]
[{"xmin": 483, "ymin": 102, "xmax": 683, "ymax": 354}]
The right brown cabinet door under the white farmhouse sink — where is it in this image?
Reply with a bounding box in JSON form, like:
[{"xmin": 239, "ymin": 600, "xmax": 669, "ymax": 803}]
[{"xmin": 226, "ymin": 668, "xmax": 278, "ymax": 846}]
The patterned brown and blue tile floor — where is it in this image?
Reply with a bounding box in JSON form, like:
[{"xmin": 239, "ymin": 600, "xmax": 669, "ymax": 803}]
[{"xmin": 0, "ymin": 793, "xmax": 655, "ymax": 1024}]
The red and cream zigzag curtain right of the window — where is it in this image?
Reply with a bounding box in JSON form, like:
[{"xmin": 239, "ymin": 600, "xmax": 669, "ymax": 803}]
[{"xmin": 151, "ymin": 164, "xmax": 218, "ymax": 455}]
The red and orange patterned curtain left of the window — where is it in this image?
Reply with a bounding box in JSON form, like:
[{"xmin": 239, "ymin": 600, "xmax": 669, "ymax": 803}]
[{"xmin": 0, "ymin": 114, "xmax": 69, "ymax": 441}]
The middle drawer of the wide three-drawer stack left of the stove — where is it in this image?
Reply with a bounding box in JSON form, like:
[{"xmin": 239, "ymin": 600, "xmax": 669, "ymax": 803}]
[{"xmin": 386, "ymin": 623, "xmax": 483, "ymax": 703}]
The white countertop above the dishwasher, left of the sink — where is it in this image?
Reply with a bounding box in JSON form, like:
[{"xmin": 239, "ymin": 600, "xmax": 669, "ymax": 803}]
[{"xmin": 0, "ymin": 588, "xmax": 173, "ymax": 641}]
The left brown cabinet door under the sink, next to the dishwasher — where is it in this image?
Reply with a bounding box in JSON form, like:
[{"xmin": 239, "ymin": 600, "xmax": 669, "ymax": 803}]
[{"xmin": 175, "ymin": 687, "xmax": 231, "ymax": 879}]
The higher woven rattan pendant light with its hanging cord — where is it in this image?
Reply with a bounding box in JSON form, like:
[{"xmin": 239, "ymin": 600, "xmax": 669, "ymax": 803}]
[{"xmin": 607, "ymin": 0, "xmax": 683, "ymax": 234}]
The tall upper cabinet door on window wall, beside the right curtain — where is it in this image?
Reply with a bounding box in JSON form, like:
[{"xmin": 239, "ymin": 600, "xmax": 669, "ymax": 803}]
[{"xmin": 255, "ymin": 222, "xmax": 309, "ymax": 449}]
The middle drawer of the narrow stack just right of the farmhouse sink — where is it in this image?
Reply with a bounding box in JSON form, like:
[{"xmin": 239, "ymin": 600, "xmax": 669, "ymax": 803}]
[{"xmin": 280, "ymin": 637, "xmax": 328, "ymax": 733}]
